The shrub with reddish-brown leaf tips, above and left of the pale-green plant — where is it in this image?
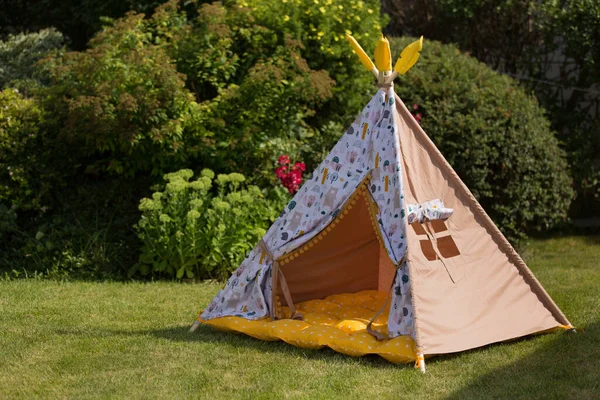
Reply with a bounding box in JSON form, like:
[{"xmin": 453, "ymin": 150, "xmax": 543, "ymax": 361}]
[{"xmin": 39, "ymin": 15, "xmax": 193, "ymax": 176}]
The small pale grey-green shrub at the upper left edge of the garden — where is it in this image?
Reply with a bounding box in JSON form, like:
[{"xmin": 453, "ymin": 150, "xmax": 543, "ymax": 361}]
[{"xmin": 0, "ymin": 29, "xmax": 64, "ymax": 89}]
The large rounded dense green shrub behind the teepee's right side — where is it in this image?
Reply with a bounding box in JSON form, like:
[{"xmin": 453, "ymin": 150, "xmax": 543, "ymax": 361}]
[{"xmin": 391, "ymin": 38, "xmax": 573, "ymax": 238}]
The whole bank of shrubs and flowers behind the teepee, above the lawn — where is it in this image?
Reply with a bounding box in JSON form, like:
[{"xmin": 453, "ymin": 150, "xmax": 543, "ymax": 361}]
[{"xmin": 0, "ymin": 0, "xmax": 600, "ymax": 280}]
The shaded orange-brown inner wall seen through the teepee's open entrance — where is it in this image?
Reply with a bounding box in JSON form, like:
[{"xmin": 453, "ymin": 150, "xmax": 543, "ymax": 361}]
[{"xmin": 280, "ymin": 196, "xmax": 380, "ymax": 303}]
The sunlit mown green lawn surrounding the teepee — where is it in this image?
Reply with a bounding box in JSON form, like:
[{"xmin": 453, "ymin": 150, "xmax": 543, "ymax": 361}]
[{"xmin": 0, "ymin": 236, "xmax": 600, "ymax": 400}]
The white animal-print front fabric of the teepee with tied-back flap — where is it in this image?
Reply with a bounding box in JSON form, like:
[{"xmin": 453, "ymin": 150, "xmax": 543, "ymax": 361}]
[{"xmin": 200, "ymin": 87, "xmax": 412, "ymax": 340}]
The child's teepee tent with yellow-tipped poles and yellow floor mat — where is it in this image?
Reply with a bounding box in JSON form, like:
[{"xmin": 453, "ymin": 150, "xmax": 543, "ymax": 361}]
[{"xmin": 192, "ymin": 38, "xmax": 572, "ymax": 371}]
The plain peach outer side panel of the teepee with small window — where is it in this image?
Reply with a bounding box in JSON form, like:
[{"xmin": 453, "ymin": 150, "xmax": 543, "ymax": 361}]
[{"xmin": 396, "ymin": 98, "xmax": 569, "ymax": 354}]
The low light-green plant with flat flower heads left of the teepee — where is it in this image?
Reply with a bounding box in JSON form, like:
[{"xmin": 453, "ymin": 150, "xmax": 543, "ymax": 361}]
[{"xmin": 136, "ymin": 169, "xmax": 285, "ymax": 279}]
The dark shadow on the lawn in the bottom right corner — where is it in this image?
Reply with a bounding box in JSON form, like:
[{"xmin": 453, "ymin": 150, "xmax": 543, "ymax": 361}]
[{"xmin": 448, "ymin": 322, "xmax": 600, "ymax": 399}]
